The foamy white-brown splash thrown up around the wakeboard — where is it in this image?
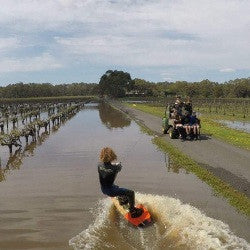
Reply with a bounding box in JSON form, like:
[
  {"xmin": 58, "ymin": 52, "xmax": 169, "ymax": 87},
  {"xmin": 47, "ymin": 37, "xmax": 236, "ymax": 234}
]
[{"xmin": 69, "ymin": 193, "xmax": 250, "ymax": 250}]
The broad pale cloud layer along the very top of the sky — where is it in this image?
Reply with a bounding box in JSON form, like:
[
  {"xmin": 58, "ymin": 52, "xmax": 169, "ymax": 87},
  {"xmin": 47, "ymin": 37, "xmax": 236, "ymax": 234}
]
[{"xmin": 0, "ymin": 0, "xmax": 250, "ymax": 37}]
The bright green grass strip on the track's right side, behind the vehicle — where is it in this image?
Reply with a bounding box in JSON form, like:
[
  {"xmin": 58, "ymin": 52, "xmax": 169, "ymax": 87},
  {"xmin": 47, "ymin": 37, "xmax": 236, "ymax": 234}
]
[{"xmin": 126, "ymin": 103, "xmax": 250, "ymax": 150}]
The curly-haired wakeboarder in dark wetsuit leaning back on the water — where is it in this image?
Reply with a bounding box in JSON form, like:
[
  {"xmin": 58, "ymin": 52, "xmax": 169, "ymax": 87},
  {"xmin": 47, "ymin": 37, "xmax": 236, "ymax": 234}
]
[{"xmin": 98, "ymin": 147, "xmax": 143, "ymax": 218}]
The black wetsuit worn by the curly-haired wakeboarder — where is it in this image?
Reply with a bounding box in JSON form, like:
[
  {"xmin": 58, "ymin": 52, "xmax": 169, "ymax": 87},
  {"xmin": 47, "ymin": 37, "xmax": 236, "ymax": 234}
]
[{"xmin": 98, "ymin": 162, "xmax": 135, "ymax": 209}]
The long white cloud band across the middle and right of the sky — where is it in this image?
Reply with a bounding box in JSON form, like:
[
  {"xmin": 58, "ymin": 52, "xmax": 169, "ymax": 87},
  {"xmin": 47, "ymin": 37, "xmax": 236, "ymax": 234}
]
[{"xmin": 55, "ymin": 35, "xmax": 250, "ymax": 69}]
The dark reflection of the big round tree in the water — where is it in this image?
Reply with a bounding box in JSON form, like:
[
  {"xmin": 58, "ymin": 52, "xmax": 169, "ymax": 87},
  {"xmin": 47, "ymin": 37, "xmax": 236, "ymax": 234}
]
[{"xmin": 99, "ymin": 103, "xmax": 131, "ymax": 129}]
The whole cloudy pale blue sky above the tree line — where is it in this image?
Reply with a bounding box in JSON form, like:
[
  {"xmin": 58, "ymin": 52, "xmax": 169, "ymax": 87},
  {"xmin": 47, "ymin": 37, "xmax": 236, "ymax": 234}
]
[{"xmin": 0, "ymin": 0, "xmax": 250, "ymax": 85}]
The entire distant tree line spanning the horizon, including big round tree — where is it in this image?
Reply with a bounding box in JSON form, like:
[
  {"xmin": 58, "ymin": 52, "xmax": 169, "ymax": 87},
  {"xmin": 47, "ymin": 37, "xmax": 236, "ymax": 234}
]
[{"xmin": 0, "ymin": 70, "xmax": 250, "ymax": 98}]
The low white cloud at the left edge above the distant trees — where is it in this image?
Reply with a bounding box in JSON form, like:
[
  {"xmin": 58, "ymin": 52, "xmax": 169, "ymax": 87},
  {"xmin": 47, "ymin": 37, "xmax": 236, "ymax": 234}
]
[{"xmin": 0, "ymin": 53, "xmax": 62, "ymax": 73}]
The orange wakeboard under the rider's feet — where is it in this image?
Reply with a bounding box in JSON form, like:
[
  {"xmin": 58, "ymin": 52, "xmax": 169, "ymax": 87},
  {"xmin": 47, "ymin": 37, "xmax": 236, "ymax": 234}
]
[{"xmin": 111, "ymin": 197, "xmax": 152, "ymax": 227}]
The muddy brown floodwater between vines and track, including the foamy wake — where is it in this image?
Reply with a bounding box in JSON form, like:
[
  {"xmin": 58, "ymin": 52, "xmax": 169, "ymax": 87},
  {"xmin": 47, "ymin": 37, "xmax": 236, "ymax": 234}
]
[{"xmin": 0, "ymin": 104, "xmax": 250, "ymax": 249}]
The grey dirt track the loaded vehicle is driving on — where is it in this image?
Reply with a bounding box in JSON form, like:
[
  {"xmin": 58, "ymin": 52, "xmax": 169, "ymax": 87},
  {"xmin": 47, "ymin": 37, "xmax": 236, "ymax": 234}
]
[{"xmin": 112, "ymin": 102, "xmax": 250, "ymax": 197}]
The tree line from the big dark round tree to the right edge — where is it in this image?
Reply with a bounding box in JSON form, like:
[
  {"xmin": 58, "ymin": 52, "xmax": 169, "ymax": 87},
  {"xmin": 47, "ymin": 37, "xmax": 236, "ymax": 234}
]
[{"xmin": 99, "ymin": 70, "xmax": 250, "ymax": 98}]
